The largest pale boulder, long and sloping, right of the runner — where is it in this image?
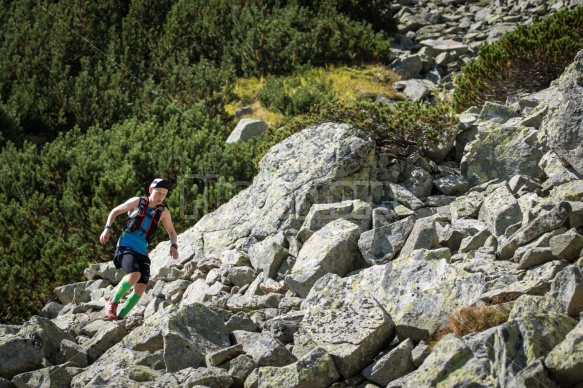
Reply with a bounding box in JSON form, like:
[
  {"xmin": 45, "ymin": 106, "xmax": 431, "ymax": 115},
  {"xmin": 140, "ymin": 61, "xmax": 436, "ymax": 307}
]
[{"xmin": 150, "ymin": 123, "xmax": 376, "ymax": 276}]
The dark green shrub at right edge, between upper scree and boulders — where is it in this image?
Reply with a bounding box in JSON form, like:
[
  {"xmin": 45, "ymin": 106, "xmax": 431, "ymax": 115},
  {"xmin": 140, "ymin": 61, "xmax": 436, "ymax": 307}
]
[{"xmin": 454, "ymin": 7, "xmax": 583, "ymax": 112}]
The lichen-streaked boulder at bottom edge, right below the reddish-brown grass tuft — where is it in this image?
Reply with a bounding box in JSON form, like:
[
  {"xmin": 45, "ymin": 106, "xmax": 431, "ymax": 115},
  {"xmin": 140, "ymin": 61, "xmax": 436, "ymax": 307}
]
[{"xmin": 402, "ymin": 313, "xmax": 577, "ymax": 388}]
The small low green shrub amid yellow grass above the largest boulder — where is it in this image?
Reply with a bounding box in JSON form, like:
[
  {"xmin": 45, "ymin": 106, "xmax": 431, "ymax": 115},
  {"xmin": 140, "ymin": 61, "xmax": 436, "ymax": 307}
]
[{"xmin": 257, "ymin": 72, "xmax": 334, "ymax": 116}]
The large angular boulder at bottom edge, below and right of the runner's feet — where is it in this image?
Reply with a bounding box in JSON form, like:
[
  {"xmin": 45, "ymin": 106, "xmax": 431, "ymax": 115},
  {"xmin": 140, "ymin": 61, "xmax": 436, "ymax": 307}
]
[{"xmin": 72, "ymin": 304, "xmax": 231, "ymax": 387}]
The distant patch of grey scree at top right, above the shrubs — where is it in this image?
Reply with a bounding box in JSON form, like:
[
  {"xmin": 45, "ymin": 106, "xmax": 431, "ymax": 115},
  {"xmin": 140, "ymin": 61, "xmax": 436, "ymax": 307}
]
[{"xmin": 391, "ymin": 0, "xmax": 583, "ymax": 100}]
